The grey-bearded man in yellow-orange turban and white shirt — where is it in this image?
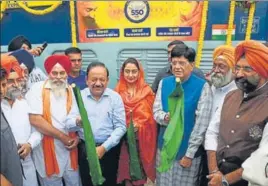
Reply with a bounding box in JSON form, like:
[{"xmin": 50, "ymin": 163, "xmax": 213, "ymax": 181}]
[{"xmin": 205, "ymin": 45, "xmax": 237, "ymax": 180}]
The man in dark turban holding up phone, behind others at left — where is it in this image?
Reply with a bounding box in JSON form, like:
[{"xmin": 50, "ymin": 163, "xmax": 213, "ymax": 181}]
[{"xmin": 8, "ymin": 35, "xmax": 47, "ymax": 88}]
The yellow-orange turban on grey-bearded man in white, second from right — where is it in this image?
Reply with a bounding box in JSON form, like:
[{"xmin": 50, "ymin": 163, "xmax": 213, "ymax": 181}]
[{"xmin": 213, "ymin": 45, "xmax": 235, "ymax": 69}]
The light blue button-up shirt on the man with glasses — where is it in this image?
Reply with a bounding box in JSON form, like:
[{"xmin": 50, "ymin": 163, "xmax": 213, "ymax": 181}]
[{"xmin": 66, "ymin": 88, "xmax": 126, "ymax": 151}]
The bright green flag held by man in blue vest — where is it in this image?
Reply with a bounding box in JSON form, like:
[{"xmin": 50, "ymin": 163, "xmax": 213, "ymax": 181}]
[{"xmin": 157, "ymin": 82, "xmax": 184, "ymax": 172}]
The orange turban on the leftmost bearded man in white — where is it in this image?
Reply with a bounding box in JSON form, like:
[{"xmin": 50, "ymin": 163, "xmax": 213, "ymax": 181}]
[{"xmin": 1, "ymin": 53, "xmax": 23, "ymax": 77}]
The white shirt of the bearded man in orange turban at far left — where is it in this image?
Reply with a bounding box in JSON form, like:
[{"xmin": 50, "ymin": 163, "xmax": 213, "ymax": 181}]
[{"xmin": 1, "ymin": 99, "xmax": 41, "ymax": 149}]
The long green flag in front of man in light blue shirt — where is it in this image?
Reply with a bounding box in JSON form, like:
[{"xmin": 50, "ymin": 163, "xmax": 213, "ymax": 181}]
[{"xmin": 73, "ymin": 86, "xmax": 105, "ymax": 186}]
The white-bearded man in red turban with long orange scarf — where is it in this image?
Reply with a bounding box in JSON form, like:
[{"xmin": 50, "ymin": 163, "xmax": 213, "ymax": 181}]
[{"xmin": 26, "ymin": 55, "xmax": 80, "ymax": 186}]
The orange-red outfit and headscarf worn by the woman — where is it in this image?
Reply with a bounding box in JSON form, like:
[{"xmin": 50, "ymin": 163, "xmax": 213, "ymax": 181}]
[{"xmin": 115, "ymin": 64, "xmax": 157, "ymax": 184}]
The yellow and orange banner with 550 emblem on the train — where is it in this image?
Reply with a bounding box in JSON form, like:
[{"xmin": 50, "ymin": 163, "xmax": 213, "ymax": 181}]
[{"xmin": 76, "ymin": 0, "xmax": 203, "ymax": 42}]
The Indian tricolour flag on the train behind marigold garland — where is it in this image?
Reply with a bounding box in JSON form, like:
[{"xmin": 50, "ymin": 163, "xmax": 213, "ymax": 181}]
[{"xmin": 212, "ymin": 24, "xmax": 236, "ymax": 40}]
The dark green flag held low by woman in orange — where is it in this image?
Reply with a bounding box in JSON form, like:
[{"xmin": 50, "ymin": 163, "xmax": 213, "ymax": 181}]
[{"xmin": 127, "ymin": 113, "xmax": 143, "ymax": 181}]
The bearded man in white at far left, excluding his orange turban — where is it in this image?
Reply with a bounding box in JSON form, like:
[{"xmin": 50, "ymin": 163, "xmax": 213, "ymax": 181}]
[{"xmin": 1, "ymin": 65, "xmax": 41, "ymax": 186}]
